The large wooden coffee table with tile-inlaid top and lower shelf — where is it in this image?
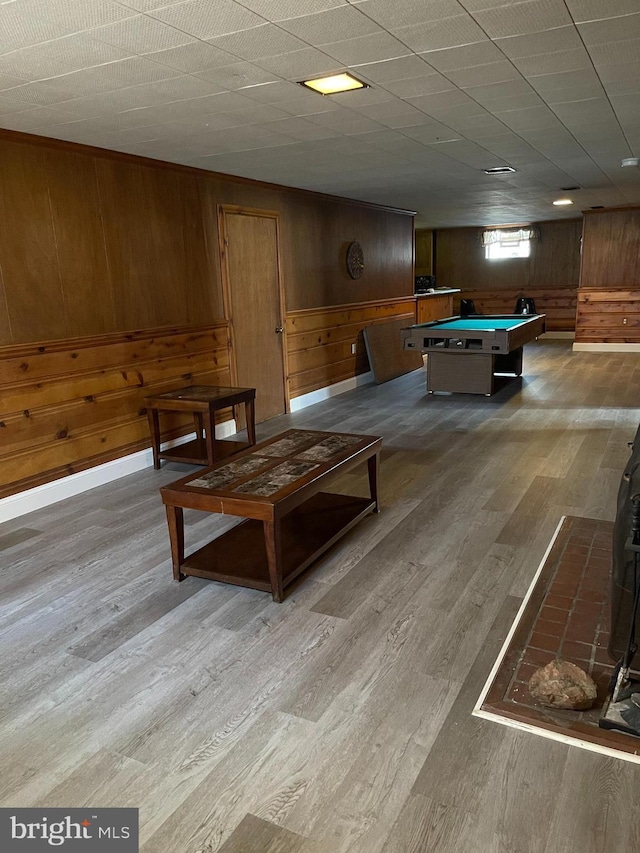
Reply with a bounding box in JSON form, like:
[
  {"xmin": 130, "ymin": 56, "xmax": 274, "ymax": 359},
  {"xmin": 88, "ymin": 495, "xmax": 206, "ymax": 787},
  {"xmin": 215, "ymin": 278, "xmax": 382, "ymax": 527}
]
[{"xmin": 160, "ymin": 429, "xmax": 382, "ymax": 601}]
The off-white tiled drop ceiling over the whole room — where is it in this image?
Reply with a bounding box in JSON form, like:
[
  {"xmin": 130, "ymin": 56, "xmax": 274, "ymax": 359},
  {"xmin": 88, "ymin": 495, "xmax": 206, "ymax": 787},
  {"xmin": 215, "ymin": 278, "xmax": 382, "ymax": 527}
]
[{"xmin": 0, "ymin": 0, "xmax": 640, "ymax": 227}]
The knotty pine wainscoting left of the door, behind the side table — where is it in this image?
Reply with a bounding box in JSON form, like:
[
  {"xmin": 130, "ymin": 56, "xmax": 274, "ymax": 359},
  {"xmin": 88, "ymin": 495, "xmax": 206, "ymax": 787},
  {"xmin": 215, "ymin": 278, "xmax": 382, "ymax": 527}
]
[{"xmin": 0, "ymin": 321, "xmax": 230, "ymax": 498}]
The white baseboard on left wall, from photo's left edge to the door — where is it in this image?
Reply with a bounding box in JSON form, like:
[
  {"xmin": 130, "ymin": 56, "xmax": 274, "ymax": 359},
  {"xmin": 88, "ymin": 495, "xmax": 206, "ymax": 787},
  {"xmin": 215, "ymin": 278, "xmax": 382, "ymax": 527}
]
[{"xmin": 0, "ymin": 420, "xmax": 236, "ymax": 523}]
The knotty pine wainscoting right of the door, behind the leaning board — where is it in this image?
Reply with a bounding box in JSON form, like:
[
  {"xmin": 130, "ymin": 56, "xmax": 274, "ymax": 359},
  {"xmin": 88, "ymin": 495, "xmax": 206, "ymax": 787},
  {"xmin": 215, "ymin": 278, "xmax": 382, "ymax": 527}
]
[{"xmin": 286, "ymin": 296, "xmax": 416, "ymax": 398}]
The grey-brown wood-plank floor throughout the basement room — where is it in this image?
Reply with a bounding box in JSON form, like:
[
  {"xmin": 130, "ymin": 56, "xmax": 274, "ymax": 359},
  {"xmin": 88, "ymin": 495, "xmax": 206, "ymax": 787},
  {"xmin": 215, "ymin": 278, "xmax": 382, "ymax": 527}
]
[{"xmin": 0, "ymin": 341, "xmax": 640, "ymax": 853}]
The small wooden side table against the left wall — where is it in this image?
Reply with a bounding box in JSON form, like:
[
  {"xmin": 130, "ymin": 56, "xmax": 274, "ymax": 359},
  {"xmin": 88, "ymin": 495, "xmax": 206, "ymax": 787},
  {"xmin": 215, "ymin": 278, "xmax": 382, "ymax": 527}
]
[{"xmin": 144, "ymin": 385, "xmax": 256, "ymax": 469}]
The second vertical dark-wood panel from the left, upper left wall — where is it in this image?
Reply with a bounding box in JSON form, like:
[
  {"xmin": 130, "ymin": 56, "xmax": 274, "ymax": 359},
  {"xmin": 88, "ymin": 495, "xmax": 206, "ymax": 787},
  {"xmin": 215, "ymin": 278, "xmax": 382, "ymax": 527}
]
[{"xmin": 45, "ymin": 149, "xmax": 116, "ymax": 335}]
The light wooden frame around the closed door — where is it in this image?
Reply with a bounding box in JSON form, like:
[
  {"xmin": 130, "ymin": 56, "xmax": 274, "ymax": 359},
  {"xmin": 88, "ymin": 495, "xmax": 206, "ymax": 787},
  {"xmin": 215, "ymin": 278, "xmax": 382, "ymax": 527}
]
[{"xmin": 217, "ymin": 204, "xmax": 291, "ymax": 414}]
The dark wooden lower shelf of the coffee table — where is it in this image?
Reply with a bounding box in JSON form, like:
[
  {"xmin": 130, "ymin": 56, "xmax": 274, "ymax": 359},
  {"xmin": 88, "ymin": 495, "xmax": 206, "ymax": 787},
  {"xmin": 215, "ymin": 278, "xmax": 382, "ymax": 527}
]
[{"xmin": 180, "ymin": 492, "xmax": 376, "ymax": 592}]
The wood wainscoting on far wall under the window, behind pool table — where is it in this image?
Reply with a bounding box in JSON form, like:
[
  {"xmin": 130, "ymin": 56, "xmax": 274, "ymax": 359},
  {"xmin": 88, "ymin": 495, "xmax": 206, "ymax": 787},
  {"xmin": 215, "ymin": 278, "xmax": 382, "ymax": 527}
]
[{"xmin": 453, "ymin": 287, "xmax": 577, "ymax": 332}]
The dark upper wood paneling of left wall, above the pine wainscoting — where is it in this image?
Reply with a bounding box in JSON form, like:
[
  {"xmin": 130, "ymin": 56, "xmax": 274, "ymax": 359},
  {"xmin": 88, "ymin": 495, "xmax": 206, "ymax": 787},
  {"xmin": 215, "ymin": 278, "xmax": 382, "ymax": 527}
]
[{"xmin": 0, "ymin": 131, "xmax": 413, "ymax": 346}]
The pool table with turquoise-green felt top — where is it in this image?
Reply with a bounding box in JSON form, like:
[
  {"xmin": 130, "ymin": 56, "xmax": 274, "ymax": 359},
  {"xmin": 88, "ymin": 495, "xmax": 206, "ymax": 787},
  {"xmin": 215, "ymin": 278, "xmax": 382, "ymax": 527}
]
[{"xmin": 402, "ymin": 314, "xmax": 545, "ymax": 397}]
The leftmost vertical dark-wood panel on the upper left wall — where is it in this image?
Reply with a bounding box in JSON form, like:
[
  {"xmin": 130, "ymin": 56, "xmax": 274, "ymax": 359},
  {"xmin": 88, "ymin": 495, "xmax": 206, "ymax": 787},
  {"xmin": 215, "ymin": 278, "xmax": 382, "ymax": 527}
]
[{"xmin": 0, "ymin": 140, "xmax": 68, "ymax": 342}]
